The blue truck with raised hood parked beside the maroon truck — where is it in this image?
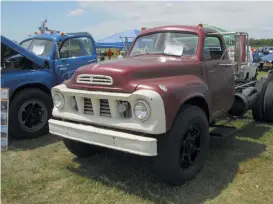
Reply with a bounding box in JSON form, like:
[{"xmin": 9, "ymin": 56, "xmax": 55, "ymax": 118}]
[{"xmin": 1, "ymin": 32, "xmax": 97, "ymax": 139}]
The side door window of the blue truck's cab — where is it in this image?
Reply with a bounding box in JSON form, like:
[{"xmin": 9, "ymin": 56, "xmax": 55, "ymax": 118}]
[{"xmin": 60, "ymin": 37, "xmax": 93, "ymax": 58}]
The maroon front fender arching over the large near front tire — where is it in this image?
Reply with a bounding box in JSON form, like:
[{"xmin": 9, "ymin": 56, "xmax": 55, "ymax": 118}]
[{"xmin": 136, "ymin": 75, "xmax": 210, "ymax": 130}]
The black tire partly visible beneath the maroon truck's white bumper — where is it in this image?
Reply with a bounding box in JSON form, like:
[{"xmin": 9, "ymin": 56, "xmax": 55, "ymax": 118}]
[{"xmin": 63, "ymin": 138, "xmax": 105, "ymax": 158}]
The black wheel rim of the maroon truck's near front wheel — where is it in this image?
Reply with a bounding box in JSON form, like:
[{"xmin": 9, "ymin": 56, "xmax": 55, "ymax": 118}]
[{"xmin": 179, "ymin": 125, "xmax": 202, "ymax": 170}]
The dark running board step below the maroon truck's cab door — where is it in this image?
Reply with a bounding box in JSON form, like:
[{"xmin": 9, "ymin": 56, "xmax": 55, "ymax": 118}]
[{"xmin": 210, "ymin": 125, "xmax": 237, "ymax": 139}]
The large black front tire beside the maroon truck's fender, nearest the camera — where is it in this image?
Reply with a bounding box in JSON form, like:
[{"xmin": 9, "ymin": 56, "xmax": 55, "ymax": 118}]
[{"xmin": 155, "ymin": 105, "xmax": 209, "ymax": 185}]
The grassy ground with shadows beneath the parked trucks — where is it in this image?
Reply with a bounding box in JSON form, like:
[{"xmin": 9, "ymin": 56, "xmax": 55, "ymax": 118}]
[{"xmin": 1, "ymin": 71, "xmax": 273, "ymax": 204}]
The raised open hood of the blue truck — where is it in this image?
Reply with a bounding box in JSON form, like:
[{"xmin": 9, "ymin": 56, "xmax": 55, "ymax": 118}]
[{"xmin": 1, "ymin": 35, "xmax": 44, "ymax": 67}]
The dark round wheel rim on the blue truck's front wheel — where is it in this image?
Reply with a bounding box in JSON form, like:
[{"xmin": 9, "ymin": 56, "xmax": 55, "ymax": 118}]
[{"xmin": 18, "ymin": 100, "xmax": 47, "ymax": 132}]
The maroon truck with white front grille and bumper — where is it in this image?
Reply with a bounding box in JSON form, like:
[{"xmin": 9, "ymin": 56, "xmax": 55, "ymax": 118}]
[{"xmin": 49, "ymin": 24, "xmax": 273, "ymax": 185}]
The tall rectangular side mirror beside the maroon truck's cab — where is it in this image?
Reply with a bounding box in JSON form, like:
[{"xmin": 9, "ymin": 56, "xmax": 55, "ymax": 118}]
[{"xmin": 234, "ymin": 33, "xmax": 247, "ymax": 63}]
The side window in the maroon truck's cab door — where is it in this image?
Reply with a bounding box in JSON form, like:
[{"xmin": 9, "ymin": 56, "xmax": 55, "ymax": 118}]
[{"xmin": 203, "ymin": 36, "xmax": 227, "ymax": 60}]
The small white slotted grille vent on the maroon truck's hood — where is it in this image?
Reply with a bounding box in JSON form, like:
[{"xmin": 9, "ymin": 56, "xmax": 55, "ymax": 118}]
[{"xmin": 77, "ymin": 74, "xmax": 113, "ymax": 85}]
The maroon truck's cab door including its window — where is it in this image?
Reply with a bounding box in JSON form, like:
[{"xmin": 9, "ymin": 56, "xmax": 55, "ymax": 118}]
[{"xmin": 203, "ymin": 35, "xmax": 235, "ymax": 117}]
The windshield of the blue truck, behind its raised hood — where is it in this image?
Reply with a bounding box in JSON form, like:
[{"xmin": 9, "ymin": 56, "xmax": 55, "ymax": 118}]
[{"xmin": 21, "ymin": 39, "xmax": 54, "ymax": 57}]
